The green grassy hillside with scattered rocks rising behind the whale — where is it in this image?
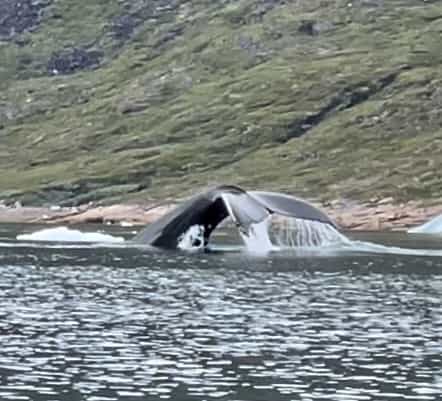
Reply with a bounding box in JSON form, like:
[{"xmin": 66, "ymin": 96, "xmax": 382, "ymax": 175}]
[{"xmin": 0, "ymin": 0, "xmax": 442, "ymax": 204}]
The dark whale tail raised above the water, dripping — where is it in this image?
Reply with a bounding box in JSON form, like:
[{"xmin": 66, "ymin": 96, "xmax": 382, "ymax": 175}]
[{"xmin": 133, "ymin": 185, "xmax": 336, "ymax": 249}]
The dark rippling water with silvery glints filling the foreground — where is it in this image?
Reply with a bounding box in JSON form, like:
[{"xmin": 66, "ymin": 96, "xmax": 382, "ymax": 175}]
[{"xmin": 0, "ymin": 226, "xmax": 442, "ymax": 401}]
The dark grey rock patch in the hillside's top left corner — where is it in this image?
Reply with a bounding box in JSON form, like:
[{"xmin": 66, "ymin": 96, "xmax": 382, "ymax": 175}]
[{"xmin": 0, "ymin": 0, "xmax": 51, "ymax": 39}]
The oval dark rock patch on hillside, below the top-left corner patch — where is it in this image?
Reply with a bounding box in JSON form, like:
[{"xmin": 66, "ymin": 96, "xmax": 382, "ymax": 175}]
[{"xmin": 47, "ymin": 48, "xmax": 103, "ymax": 75}]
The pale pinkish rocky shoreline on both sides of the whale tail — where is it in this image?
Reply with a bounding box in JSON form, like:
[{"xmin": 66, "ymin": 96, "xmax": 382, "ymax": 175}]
[{"xmin": 0, "ymin": 199, "xmax": 442, "ymax": 231}]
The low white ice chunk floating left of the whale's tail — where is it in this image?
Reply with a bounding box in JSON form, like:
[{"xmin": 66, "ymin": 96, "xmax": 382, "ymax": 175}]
[{"xmin": 17, "ymin": 227, "xmax": 124, "ymax": 243}]
